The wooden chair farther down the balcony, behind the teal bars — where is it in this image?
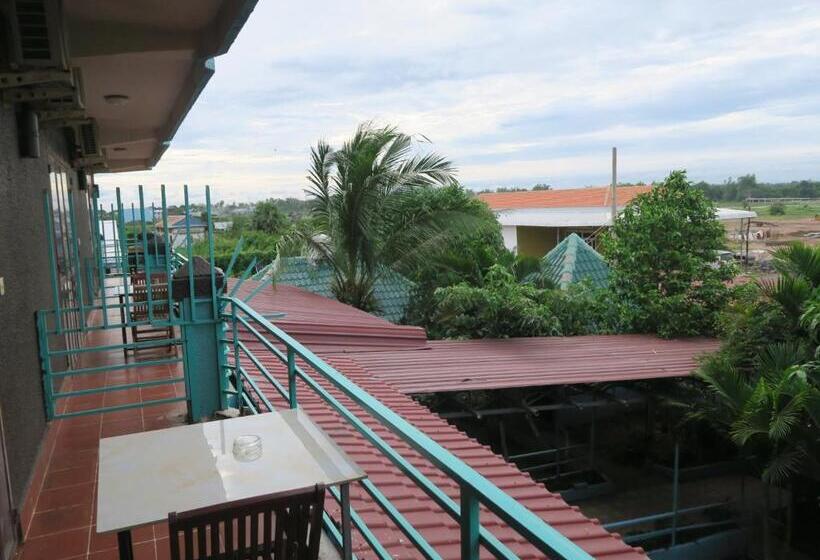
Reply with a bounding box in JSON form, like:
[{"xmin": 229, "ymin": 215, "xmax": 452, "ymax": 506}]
[{"xmin": 131, "ymin": 272, "xmax": 177, "ymax": 355}]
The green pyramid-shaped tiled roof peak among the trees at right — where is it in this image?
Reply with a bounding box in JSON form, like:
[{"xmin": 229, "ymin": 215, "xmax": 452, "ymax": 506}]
[{"xmin": 541, "ymin": 233, "xmax": 609, "ymax": 289}]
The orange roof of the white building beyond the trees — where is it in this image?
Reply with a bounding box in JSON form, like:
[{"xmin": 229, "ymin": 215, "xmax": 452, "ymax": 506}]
[{"xmin": 478, "ymin": 185, "xmax": 652, "ymax": 210}]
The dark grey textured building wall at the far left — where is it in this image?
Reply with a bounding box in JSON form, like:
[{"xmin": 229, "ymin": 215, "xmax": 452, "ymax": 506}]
[{"xmin": 0, "ymin": 105, "xmax": 91, "ymax": 506}]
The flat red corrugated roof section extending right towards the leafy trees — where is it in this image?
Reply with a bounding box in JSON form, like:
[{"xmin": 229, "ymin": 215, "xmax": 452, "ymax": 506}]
[{"xmin": 344, "ymin": 335, "xmax": 719, "ymax": 394}]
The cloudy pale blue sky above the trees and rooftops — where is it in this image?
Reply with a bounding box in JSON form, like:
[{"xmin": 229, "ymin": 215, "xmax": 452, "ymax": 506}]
[{"xmin": 98, "ymin": 0, "xmax": 820, "ymax": 205}]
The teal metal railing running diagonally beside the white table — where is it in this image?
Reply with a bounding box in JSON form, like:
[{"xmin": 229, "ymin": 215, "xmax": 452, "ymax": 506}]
[{"xmin": 215, "ymin": 295, "xmax": 592, "ymax": 560}]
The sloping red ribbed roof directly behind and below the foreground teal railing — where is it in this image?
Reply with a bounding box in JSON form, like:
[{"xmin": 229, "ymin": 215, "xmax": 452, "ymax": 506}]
[{"xmin": 237, "ymin": 350, "xmax": 646, "ymax": 560}]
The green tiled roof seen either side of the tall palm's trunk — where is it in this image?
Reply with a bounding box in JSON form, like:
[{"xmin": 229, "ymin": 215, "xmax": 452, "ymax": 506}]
[{"xmin": 276, "ymin": 257, "xmax": 413, "ymax": 323}]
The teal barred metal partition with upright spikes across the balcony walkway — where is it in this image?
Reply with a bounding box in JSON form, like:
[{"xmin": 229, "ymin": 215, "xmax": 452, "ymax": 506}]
[{"xmin": 37, "ymin": 185, "xmax": 219, "ymax": 419}]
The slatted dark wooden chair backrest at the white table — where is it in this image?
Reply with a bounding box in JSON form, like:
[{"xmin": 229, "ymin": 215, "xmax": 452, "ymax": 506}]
[{"xmin": 168, "ymin": 485, "xmax": 325, "ymax": 560}]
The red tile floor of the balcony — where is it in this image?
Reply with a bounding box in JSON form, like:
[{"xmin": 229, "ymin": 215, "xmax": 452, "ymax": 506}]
[{"xmin": 17, "ymin": 306, "xmax": 185, "ymax": 560}]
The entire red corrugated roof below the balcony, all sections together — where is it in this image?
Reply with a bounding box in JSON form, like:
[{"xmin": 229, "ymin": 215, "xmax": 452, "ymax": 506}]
[{"xmin": 232, "ymin": 280, "xmax": 717, "ymax": 560}]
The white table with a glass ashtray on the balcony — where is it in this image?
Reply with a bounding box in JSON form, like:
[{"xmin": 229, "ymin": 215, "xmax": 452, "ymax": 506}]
[{"xmin": 97, "ymin": 409, "xmax": 366, "ymax": 560}]
